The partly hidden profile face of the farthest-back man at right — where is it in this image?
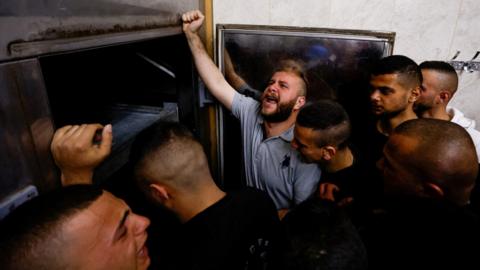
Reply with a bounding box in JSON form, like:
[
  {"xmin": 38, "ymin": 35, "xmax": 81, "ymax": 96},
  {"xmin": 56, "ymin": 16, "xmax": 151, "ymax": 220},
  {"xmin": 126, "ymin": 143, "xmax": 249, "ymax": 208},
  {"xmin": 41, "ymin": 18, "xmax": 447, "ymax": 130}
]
[{"xmin": 415, "ymin": 69, "xmax": 439, "ymax": 111}]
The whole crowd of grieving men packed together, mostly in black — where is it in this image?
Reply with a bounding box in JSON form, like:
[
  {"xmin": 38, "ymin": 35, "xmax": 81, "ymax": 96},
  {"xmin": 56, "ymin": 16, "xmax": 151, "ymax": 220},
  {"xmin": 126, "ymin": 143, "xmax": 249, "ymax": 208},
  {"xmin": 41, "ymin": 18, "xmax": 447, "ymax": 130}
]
[{"xmin": 0, "ymin": 11, "xmax": 480, "ymax": 270}]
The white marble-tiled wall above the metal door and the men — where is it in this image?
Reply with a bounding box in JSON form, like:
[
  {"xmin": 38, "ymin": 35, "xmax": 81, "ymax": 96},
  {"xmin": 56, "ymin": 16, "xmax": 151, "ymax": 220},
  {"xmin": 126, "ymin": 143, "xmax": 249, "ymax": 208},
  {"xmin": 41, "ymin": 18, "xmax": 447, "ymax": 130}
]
[{"xmin": 213, "ymin": 0, "xmax": 480, "ymax": 124}]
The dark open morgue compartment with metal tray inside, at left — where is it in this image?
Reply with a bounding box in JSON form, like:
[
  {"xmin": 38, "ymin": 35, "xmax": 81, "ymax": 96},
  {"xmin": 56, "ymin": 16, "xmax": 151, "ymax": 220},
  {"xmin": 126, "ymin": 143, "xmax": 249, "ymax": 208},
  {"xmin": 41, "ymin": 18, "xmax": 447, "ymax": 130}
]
[{"xmin": 39, "ymin": 35, "xmax": 197, "ymax": 184}]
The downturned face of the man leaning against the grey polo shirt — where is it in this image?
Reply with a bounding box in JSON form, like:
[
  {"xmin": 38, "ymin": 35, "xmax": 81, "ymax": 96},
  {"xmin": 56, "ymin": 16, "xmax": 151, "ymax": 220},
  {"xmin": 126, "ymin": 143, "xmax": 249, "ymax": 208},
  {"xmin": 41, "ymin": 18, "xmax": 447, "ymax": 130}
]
[{"xmin": 291, "ymin": 124, "xmax": 323, "ymax": 163}]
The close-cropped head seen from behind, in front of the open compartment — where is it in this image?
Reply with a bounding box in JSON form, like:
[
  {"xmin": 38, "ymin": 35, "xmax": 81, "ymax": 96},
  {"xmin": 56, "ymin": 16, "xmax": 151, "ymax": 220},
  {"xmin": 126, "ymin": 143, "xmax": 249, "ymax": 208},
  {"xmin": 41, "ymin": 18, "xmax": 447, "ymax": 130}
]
[{"xmin": 132, "ymin": 123, "xmax": 210, "ymax": 191}]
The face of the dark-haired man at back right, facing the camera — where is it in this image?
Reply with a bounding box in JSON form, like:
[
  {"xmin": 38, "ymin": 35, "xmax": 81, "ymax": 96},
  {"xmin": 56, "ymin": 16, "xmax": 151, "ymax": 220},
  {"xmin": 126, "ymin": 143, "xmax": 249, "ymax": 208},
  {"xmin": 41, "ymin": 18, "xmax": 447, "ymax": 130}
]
[{"xmin": 370, "ymin": 74, "xmax": 412, "ymax": 116}]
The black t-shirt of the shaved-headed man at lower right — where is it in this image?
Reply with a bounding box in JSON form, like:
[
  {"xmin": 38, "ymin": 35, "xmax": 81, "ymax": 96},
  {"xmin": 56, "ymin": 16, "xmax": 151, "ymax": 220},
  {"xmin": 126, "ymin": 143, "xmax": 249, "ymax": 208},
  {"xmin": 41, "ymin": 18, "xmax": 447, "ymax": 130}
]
[{"xmin": 363, "ymin": 197, "xmax": 480, "ymax": 269}]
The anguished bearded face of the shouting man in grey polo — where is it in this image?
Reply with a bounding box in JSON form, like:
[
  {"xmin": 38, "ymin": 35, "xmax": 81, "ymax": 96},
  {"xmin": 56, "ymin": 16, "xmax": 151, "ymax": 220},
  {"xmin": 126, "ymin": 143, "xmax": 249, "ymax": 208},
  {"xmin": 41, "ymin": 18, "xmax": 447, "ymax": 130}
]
[{"xmin": 261, "ymin": 71, "xmax": 303, "ymax": 122}]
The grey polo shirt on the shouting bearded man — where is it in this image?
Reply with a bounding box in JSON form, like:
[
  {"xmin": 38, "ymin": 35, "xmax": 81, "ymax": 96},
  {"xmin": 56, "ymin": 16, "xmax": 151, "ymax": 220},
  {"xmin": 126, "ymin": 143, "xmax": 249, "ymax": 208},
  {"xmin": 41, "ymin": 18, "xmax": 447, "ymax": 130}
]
[{"xmin": 232, "ymin": 93, "xmax": 320, "ymax": 209}]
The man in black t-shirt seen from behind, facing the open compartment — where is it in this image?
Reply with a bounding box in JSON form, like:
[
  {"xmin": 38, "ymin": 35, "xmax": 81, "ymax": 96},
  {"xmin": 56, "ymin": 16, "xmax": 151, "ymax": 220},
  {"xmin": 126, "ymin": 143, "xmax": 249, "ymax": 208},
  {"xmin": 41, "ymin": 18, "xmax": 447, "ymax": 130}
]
[{"xmin": 132, "ymin": 123, "xmax": 280, "ymax": 269}]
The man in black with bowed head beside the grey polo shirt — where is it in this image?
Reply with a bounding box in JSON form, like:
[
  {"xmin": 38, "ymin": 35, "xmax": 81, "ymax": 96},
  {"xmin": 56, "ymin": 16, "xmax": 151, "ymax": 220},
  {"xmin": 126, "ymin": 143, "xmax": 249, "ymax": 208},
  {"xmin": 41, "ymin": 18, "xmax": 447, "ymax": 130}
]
[{"xmin": 292, "ymin": 100, "xmax": 382, "ymax": 211}]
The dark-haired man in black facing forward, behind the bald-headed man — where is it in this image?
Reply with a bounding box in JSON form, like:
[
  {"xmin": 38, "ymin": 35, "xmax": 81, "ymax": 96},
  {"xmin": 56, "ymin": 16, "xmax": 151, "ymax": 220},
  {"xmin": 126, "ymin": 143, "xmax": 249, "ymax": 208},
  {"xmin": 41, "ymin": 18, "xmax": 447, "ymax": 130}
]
[{"xmin": 362, "ymin": 55, "xmax": 422, "ymax": 171}]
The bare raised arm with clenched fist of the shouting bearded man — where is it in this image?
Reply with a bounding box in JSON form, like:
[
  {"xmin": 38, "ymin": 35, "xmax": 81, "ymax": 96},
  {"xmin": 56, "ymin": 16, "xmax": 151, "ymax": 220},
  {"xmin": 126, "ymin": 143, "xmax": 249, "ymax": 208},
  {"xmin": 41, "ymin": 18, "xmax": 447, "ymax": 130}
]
[{"xmin": 182, "ymin": 10, "xmax": 235, "ymax": 110}]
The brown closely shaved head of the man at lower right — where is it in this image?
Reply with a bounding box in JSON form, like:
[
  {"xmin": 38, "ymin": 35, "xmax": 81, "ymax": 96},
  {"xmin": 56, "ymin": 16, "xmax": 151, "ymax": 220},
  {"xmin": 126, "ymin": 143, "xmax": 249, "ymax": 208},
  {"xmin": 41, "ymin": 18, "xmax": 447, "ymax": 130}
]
[{"xmin": 385, "ymin": 119, "xmax": 478, "ymax": 205}]
